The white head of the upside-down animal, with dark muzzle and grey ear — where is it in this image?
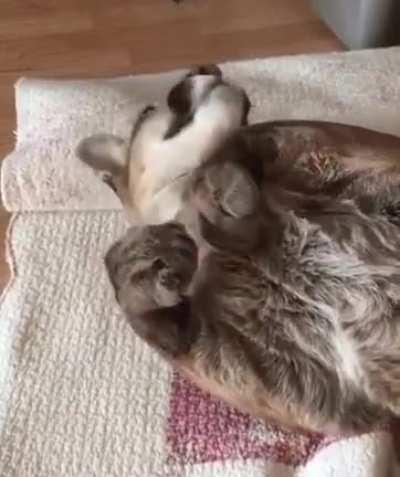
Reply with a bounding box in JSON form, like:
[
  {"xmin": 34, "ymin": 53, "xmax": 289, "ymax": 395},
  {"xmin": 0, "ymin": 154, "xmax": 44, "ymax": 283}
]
[{"xmin": 77, "ymin": 65, "xmax": 250, "ymax": 227}]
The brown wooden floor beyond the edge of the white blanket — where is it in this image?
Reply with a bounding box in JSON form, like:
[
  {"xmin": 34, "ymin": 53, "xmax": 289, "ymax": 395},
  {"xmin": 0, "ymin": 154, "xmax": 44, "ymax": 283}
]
[{"xmin": 0, "ymin": 0, "xmax": 342, "ymax": 288}]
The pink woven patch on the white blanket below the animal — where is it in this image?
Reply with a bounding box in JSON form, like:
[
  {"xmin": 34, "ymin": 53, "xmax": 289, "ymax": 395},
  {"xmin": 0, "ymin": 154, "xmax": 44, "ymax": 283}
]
[{"xmin": 167, "ymin": 374, "xmax": 334, "ymax": 466}]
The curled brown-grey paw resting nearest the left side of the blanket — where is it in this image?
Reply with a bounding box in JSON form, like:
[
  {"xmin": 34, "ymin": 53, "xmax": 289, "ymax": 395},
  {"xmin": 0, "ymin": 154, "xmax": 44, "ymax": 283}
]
[{"xmin": 105, "ymin": 222, "xmax": 197, "ymax": 313}]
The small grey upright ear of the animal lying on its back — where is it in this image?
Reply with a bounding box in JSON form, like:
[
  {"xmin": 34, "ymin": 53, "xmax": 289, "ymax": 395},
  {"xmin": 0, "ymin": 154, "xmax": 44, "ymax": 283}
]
[{"xmin": 76, "ymin": 134, "xmax": 128, "ymax": 175}]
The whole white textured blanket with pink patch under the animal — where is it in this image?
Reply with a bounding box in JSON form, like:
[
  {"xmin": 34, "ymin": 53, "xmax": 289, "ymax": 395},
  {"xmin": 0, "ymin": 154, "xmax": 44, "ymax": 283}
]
[{"xmin": 0, "ymin": 48, "xmax": 400, "ymax": 477}]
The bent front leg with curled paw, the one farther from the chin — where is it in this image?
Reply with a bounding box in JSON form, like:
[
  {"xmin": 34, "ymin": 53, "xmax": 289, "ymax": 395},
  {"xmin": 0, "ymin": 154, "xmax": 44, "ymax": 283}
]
[{"xmin": 105, "ymin": 222, "xmax": 197, "ymax": 358}]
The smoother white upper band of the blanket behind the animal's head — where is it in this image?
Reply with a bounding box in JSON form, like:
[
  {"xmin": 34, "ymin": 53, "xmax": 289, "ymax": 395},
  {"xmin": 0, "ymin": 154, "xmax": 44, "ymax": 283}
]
[{"xmin": 2, "ymin": 48, "xmax": 400, "ymax": 211}]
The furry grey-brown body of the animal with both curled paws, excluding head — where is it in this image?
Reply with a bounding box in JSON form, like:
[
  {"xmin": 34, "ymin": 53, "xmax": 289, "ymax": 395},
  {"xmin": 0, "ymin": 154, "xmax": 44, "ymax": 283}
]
[{"xmin": 78, "ymin": 65, "xmax": 400, "ymax": 433}]
